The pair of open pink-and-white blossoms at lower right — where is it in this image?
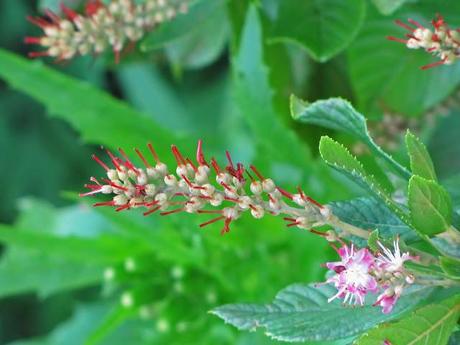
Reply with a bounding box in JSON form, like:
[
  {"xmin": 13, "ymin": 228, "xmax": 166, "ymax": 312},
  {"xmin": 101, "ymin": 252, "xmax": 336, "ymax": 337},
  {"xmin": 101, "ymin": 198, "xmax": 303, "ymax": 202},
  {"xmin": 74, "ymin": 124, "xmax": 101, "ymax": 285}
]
[{"xmin": 326, "ymin": 239, "xmax": 417, "ymax": 314}]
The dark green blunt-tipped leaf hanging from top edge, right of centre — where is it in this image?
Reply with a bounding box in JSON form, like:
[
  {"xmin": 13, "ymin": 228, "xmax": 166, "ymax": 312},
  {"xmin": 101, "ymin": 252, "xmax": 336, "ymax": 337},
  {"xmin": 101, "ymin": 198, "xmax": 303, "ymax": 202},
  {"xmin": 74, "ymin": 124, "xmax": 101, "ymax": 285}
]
[{"xmin": 271, "ymin": 0, "xmax": 366, "ymax": 62}]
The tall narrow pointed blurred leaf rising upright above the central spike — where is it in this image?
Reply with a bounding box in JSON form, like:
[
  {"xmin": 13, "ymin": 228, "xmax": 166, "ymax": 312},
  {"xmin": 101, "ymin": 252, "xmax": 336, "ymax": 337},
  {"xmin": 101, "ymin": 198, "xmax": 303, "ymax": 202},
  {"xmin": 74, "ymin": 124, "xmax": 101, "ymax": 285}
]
[{"xmin": 232, "ymin": 5, "xmax": 310, "ymax": 167}]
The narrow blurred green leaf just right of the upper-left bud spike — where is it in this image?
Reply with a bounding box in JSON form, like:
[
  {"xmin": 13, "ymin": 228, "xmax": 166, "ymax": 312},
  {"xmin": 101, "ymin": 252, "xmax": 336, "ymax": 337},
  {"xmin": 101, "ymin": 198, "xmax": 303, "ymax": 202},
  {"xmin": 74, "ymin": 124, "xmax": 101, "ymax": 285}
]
[{"xmin": 141, "ymin": 0, "xmax": 228, "ymax": 51}]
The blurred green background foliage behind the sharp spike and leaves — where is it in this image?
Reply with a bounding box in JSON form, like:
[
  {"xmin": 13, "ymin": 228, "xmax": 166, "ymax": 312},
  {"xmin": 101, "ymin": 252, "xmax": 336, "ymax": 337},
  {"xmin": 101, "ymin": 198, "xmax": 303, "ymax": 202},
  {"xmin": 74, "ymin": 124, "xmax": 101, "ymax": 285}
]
[{"xmin": 0, "ymin": 0, "xmax": 460, "ymax": 345}]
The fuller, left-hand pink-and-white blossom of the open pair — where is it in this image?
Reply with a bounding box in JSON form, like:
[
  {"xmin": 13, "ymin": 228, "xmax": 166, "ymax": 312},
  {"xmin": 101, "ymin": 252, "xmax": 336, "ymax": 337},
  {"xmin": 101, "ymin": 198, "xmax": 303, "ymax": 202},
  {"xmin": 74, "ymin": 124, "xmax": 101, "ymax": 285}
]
[{"xmin": 326, "ymin": 245, "xmax": 377, "ymax": 305}]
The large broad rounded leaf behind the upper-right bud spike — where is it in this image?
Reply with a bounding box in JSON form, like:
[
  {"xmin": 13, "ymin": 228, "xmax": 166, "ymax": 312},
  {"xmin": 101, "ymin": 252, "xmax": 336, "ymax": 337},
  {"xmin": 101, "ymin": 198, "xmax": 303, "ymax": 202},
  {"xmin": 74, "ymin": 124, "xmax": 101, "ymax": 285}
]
[{"xmin": 347, "ymin": 0, "xmax": 460, "ymax": 116}]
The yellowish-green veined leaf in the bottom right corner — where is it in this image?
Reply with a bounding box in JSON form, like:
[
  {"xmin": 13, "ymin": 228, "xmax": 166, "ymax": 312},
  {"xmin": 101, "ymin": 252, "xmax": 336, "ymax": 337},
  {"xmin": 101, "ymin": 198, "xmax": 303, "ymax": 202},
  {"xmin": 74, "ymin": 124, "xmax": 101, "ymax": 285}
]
[{"xmin": 354, "ymin": 295, "xmax": 460, "ymax": 345}]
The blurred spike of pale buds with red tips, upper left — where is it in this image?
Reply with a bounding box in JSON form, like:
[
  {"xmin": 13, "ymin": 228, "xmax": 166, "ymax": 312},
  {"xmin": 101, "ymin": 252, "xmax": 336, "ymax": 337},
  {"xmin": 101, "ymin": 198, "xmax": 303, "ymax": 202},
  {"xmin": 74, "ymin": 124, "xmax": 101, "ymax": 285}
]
[{"xmin": 25, "ymin": 0, "xmax": 189, "ymax": 62}]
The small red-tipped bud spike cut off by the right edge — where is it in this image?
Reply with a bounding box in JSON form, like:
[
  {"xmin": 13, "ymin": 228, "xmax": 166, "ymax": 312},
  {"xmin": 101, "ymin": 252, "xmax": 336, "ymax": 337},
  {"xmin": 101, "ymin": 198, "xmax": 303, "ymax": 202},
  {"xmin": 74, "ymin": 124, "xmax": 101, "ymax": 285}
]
[{"xmin": 387, "ymin": 15, "xmax": 460, "ymax": 69}]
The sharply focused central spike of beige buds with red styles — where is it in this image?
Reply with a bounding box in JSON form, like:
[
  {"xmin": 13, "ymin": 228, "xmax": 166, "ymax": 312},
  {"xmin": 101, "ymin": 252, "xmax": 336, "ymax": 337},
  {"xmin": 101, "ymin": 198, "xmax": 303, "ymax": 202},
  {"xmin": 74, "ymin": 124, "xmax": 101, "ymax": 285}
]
[{"xmin": 81, "ymin": 140, "xmax": 333, "ymax": 234}]
